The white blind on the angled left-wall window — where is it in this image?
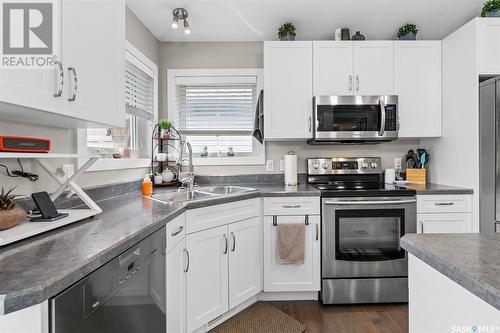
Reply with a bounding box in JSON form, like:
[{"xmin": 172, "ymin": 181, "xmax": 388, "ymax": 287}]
[{"xmin": 125, "ymin": 61, "xmax": 154, "ymax": 120}]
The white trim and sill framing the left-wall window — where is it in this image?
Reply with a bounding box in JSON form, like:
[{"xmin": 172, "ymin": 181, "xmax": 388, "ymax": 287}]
[{"xmin": 77, "ymin": 40, "xmax": 159, "ymax": 172}]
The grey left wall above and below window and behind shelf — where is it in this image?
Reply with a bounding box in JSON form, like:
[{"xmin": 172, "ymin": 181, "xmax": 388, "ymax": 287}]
[{"xmin": 0, "ymin": 8, "xmax": 159, "ymax": 195}]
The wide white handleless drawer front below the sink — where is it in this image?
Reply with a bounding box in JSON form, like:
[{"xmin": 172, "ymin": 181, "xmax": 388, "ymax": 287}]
[{"xmin": 186, "ymin": 198, "xmax": 260, "ymax": 234}]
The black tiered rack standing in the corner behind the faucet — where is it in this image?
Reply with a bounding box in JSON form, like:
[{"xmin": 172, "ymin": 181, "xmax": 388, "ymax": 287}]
[{"xmin": 151, "ymin": 124, "xmax": 182, "ymax": 187}]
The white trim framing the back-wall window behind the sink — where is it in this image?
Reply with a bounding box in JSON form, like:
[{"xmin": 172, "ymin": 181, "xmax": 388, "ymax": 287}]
[{"xmin": 167, "ymin": 68, "xmax": 266, "ymax": 165}]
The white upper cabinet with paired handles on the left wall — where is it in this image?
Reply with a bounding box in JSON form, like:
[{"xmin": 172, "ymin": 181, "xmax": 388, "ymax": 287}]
[{"xmin": 0, "ymin": 0, "xmax": 125, "ymax": 128}]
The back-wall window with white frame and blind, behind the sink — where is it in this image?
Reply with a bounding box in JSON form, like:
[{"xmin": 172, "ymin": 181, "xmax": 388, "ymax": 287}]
[{"xmin": 167, "ymin": 69, "xmax": 265, "ymax": 165}]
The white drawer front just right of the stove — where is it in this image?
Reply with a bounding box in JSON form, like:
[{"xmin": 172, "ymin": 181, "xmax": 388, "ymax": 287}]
[{"xmin": 417, "ymin": 194, "xmax": 472, "ymax": 214}]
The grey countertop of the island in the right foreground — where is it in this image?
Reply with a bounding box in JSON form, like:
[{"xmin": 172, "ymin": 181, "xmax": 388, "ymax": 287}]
[{"xmin": 401, "ymin": 233, "xmax": 500, "ymax": 310}]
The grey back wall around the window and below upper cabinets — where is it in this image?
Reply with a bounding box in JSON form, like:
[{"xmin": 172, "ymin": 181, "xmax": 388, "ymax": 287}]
[{"xmin": 160, "ymin": 42, "xmax": 419, "ymax": 175}]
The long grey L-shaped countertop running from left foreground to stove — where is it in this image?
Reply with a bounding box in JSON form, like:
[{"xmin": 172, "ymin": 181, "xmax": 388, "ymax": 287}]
[{"xmin": 0, "ymin": 184, "xmax": 320, "ymax": 315}]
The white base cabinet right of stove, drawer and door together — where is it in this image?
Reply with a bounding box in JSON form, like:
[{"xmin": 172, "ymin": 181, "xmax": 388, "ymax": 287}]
[{"xmin": 417, "ymin": 194, "xmax": 472, "ymax": 234}]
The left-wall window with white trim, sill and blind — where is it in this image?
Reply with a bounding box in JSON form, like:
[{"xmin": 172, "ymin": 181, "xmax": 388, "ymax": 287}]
[{"xmin": 78, "ymin": 42, "xmax": 158, "ymax": 171}]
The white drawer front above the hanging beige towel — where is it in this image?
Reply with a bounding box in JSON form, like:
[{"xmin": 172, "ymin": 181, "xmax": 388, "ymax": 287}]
[{"xmin": 264, "ymin": 197, "xmax": 320, "ymax": 215}]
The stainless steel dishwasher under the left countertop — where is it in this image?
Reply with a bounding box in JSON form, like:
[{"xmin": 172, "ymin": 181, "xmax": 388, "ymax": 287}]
[{"xmin": 50, "ymin": 227, "xmax": 166, "ymax": 333}]
